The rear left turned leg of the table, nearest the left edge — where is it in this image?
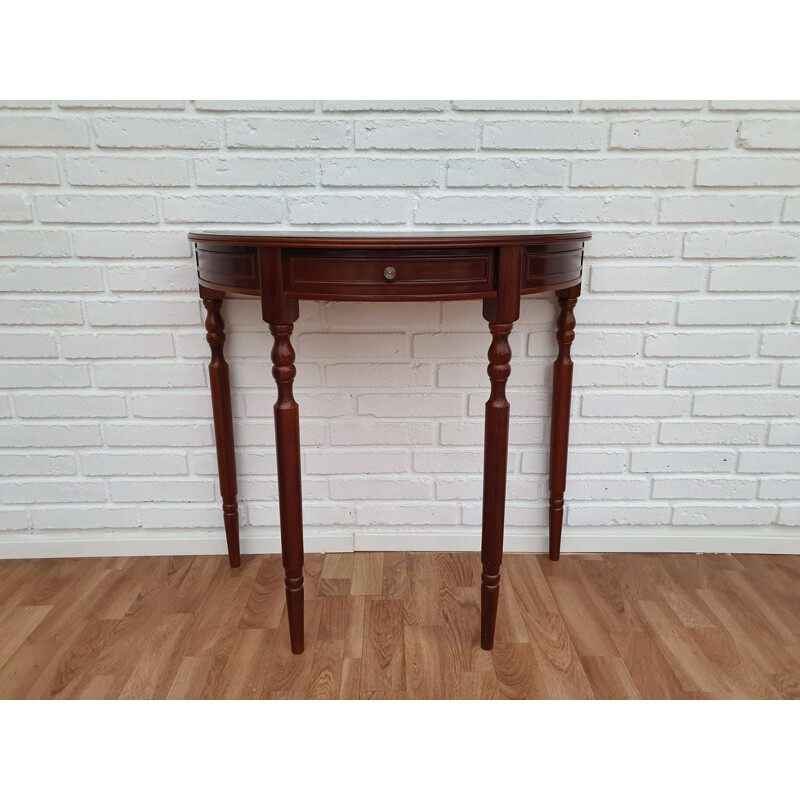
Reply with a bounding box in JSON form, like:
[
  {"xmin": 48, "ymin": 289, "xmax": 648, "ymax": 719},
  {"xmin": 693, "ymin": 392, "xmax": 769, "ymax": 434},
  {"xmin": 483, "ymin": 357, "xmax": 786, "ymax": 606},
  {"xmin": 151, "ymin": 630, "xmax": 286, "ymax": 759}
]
[{"xmin": 200, "ymin": 287, "xmax": 241, "ymax": 567}]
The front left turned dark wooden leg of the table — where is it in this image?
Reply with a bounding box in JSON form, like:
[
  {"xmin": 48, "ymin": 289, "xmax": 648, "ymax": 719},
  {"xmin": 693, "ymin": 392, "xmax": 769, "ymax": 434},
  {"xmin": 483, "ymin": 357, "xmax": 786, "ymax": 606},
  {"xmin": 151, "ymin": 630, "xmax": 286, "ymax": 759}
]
[{"xmin": 269, "ymin": 323, "xmax": 304, "ymax": 653}]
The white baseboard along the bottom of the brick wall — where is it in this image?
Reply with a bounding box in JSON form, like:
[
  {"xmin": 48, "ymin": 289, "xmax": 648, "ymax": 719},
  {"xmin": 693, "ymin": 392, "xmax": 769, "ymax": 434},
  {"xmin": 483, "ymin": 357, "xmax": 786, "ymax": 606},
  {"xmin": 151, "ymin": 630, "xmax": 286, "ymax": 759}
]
[{"xmin": 0, "ymin": 526, "xmax": 800, "ymax": 559}]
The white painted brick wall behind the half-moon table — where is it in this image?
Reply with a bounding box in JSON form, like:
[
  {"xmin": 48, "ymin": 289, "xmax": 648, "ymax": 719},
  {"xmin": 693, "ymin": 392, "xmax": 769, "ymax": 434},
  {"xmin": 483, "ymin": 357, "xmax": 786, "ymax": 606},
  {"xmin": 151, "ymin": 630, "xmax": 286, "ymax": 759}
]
[{"xmin": 0, "ymin": 100, "xmax": 800, "ymax": 557}]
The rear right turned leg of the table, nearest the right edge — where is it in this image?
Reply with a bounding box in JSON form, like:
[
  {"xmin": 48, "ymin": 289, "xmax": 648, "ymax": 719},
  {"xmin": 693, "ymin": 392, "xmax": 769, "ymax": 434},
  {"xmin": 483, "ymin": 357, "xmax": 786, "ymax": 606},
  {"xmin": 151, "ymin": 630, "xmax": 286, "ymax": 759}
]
[{"xmin": 550, "ymin": 285, "xmax": 581, "ymax": 561}]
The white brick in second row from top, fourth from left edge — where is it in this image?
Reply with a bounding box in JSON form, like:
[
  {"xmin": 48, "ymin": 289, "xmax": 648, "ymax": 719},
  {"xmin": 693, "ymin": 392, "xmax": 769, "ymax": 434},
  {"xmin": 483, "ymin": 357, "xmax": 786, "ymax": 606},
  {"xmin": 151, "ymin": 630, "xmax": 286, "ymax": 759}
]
[{"xmin": 355, "ymin": 119, "xmax": 476, "ymax": 150}]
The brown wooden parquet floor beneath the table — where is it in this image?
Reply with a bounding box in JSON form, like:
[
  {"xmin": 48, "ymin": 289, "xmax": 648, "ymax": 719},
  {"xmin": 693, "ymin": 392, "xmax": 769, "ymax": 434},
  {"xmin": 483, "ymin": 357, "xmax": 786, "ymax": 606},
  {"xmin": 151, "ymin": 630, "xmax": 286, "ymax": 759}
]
[{"xmin": 0, "ymin": 553, "xmax": 800, "ymax": 699}]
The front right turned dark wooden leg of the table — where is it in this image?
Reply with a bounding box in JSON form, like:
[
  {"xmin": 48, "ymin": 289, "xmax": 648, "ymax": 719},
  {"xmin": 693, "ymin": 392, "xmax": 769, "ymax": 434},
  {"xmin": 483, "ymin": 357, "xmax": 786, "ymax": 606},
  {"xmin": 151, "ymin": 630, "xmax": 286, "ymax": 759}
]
[{"xmin": 481, "ymin": 322, "xmax": 513, "ymax": 650}]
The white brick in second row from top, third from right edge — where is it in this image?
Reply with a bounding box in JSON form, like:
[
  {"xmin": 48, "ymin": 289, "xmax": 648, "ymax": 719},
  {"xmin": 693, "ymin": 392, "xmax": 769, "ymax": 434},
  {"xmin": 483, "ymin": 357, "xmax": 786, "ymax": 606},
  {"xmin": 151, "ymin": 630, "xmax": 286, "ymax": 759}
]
[{"xmin": 481, "ymin": 119, "xmax": 606, "ymax": 150}]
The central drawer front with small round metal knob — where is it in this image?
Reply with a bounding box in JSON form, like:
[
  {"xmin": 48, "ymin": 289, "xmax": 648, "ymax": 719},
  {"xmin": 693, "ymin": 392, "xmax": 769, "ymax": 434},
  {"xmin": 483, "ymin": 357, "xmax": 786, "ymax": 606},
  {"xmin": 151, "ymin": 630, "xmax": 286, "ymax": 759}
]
[{"xmin": 283, "ymin": 248, "xmax": 495, "ymax": 299}]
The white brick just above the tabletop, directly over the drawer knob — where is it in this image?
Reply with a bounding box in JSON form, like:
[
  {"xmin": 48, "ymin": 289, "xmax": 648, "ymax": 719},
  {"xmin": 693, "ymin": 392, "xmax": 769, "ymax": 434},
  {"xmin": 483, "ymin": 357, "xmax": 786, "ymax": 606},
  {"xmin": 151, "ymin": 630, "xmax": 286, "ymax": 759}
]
[{"xmin": 289, "ymin": 194, "xmax": 408, "ymax": 225}]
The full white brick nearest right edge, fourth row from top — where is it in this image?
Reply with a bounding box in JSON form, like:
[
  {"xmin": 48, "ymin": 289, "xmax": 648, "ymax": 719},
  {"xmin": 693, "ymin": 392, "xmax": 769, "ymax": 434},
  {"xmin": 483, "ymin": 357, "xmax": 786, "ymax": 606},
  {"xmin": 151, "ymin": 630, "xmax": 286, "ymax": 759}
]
[{"xmin": 658, "ymin": 194, "xmax": 781, "ymax": 223}]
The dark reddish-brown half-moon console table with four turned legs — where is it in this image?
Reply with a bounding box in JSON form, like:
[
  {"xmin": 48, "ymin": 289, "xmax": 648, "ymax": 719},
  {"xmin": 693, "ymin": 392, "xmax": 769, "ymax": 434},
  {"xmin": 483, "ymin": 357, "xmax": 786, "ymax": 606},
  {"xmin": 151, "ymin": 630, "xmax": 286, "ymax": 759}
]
[{"xmin": 189, "ymin": 230, "xmax": 591, "ymax": 653}]
